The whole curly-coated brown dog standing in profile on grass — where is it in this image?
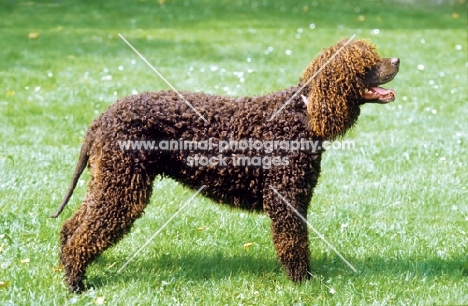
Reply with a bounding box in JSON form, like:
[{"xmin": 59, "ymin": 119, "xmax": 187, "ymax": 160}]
[{"xmin": 52, "ymin": 40, "xmax": 399, "ymax": 292}]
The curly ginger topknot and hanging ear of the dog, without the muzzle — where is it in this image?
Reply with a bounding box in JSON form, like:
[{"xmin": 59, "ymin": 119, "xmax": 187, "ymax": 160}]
[{"xmin": 300, "ymin": 40, "xmax": 380, "ymax": 139}]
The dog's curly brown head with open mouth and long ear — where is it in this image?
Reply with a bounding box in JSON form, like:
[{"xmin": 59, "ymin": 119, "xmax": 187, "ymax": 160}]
[{"xmin": 300, "ymin": 40, "xmax": 400, "ymax": 139}]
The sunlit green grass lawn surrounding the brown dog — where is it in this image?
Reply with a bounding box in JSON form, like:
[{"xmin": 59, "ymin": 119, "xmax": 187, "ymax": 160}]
[{"xmin": 0, "ymin": 0, "xmax": 468, "ymax": 305}]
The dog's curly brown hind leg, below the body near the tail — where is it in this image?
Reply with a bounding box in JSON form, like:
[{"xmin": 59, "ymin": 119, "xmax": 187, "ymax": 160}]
[{"xmin": 61, "ymin": 165, "xmax": 152, "ymax": 292}]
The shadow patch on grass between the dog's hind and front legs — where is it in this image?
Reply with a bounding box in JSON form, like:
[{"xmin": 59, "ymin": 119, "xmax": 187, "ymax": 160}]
[{"xmin": 87, "ymin": 252, "xmax": 282, "ymax": 288}]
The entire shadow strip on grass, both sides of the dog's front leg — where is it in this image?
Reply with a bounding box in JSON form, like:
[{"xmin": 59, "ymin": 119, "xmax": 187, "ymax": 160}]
[{"xmin": 82, "ymin": 252, "xmax": 468, "ymax": 288}]
